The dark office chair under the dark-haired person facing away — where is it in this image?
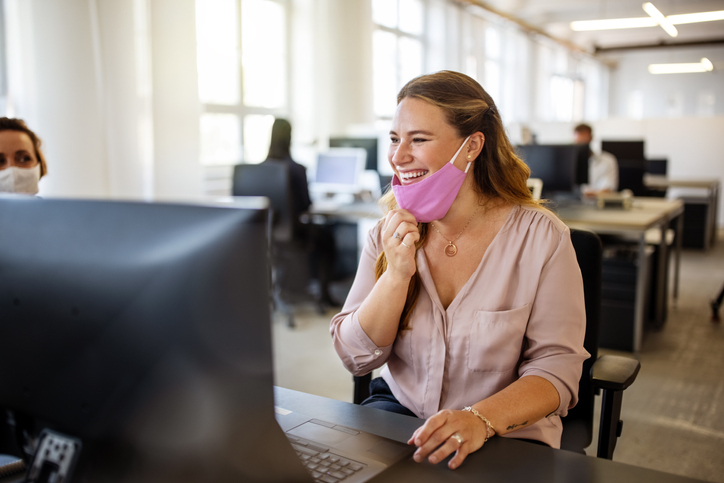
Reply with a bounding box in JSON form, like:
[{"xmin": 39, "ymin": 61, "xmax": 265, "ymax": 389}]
[{"xmin": 232, "ymin": 161, "xmax": 312, "ymax": 327}]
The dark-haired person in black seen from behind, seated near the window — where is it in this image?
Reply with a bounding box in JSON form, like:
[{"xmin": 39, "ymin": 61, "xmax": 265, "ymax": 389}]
[{"xmin": 264, "ymin": 118, "xmax": 339, "ymax": 307}]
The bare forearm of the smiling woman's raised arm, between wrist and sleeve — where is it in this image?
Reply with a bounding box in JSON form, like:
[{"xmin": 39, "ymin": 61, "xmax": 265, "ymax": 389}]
[{"xmin": 357, "ymin": 271, "xmax": 410, "ymax": 347}]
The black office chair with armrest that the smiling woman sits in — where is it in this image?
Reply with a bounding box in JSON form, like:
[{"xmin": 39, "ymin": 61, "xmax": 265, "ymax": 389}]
[{"xmin": 353, "ymin": 230, "xmax": 641, "ymax": 459}]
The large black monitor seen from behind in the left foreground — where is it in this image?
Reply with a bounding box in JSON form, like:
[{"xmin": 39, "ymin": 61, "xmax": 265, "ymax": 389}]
[{"xmin": 0, "ymin": 197, "xmax": 308, "ymax": 482}]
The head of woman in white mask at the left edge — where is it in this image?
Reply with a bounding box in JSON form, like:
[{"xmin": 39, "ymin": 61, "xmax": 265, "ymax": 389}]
[{"xmin": 0, "ymin": 117, "xmax": 48, "ymax": 195}]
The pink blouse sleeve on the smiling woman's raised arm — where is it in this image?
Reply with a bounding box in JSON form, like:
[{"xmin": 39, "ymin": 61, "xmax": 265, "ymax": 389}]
[{"xmin": 330, "ymin": 224, "xmax": 392, "ymax": 376}]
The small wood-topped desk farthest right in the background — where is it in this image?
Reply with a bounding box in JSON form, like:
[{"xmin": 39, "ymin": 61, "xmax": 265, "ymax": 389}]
[{"xmin": 644, "ymin": 175, "xmax": 721, "ymax": 250}]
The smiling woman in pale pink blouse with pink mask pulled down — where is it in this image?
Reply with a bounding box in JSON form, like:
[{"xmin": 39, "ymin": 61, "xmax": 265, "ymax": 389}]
[{"xmin": 330, "ymin": 71, "xmax": 588, "ymax": 469}]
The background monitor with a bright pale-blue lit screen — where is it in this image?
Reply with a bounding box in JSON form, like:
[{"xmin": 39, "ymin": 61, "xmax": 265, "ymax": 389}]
[{"xmin": 310, "ymin": 148, "xmax": 367, "ymax": 194}]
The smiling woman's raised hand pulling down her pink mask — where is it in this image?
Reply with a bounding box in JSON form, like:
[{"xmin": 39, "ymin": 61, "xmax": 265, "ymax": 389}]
[{"xmin": 382, "ymin": 209, "xmax": 420, "ymax": 279}]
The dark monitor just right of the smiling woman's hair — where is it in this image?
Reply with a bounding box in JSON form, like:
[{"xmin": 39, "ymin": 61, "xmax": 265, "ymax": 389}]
[{"xmin": 516, "ymin": 144, "xmax": 590, "ymax": 198}]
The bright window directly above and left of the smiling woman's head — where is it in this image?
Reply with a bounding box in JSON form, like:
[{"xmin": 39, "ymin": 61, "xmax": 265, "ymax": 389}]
[{"xmin": 372, "ymin": 0, "xmax": 425, "ymax": 118}]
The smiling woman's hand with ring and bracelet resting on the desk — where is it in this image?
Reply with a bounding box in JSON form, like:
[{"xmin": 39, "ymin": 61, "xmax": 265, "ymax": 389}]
[{"xmin": 407, "ymin": 409, "xmax": 488, "ymax": 470}]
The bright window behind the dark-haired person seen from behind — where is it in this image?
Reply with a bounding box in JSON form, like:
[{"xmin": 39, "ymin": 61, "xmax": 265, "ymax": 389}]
[{"xmin": 196, "ymin": 0, "xmax": 289, "ymax": 172}]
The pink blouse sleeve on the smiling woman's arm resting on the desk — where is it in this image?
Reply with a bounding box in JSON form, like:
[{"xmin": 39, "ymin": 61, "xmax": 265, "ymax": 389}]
[{"xmin": 518, "ymin": 228, "xmax": 589, "ymax": 416}]
